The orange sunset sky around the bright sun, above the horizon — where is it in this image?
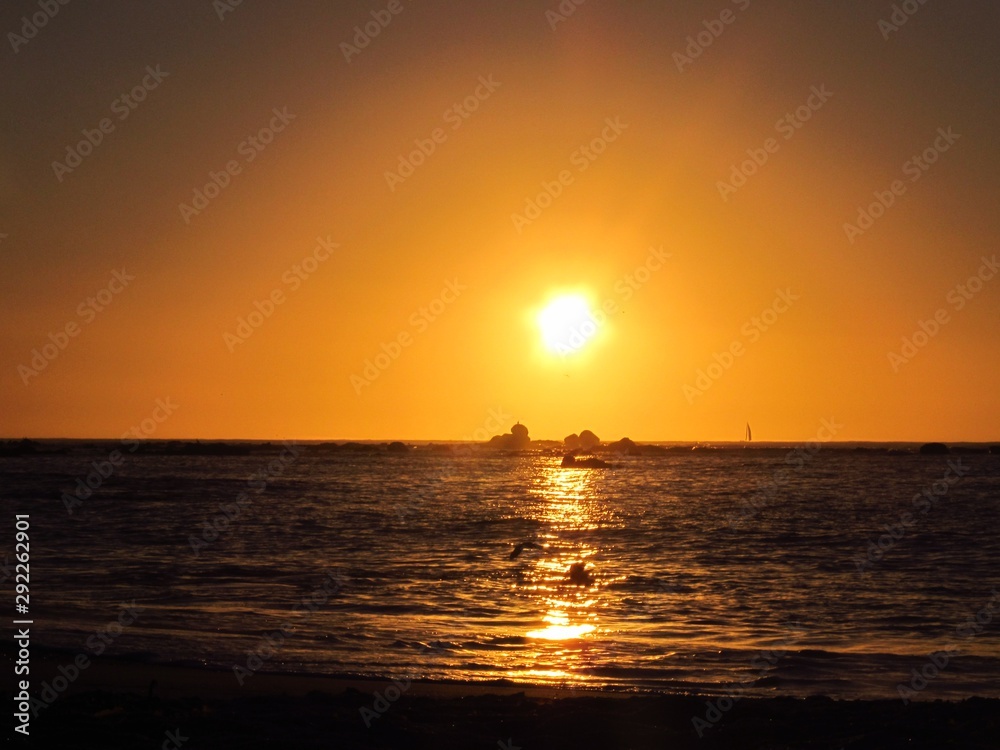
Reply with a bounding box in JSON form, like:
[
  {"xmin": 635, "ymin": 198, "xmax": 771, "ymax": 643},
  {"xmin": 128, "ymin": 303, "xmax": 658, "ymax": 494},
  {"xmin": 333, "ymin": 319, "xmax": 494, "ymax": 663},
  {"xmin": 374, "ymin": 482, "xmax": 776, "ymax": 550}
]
[{"xmin": 0, "ymin": 0, "xmax": 1000, "ymax": 441}]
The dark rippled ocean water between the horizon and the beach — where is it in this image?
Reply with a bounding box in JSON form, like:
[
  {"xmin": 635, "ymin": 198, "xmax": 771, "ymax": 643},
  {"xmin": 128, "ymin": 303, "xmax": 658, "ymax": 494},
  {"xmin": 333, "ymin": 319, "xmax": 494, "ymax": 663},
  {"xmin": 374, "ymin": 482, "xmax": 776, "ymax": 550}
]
[{"xmin": 0, "ymin": 444, "xmax": 1000, "ymax": 699}]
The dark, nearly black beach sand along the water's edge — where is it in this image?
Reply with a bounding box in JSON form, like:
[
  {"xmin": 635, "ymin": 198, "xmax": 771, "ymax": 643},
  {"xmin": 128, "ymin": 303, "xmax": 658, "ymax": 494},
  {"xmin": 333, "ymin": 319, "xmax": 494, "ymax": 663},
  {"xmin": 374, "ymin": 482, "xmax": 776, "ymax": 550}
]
[{"xmin": 15, "ymin": 651, "xmax": 1000, "ymax": 750}]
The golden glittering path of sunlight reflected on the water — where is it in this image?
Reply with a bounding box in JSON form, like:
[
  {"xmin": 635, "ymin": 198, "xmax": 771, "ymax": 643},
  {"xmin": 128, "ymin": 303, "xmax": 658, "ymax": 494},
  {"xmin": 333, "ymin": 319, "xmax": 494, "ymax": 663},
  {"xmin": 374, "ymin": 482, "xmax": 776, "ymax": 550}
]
[{"xmin": 508, "ymin": 460, "xmax": 610, "ymax": 682}]
